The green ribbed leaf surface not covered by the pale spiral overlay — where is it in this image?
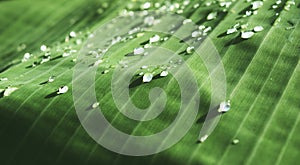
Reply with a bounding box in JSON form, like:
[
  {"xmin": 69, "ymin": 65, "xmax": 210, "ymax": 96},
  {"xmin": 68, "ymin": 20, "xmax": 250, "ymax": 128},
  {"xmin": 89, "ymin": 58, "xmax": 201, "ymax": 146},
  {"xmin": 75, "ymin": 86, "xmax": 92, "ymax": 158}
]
[{"xmin": 0, "ymin": 0, "xmax": 300, "ymax": 164}]
